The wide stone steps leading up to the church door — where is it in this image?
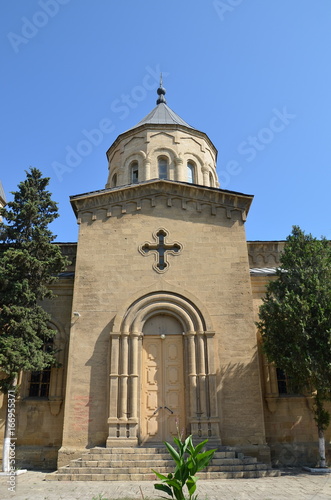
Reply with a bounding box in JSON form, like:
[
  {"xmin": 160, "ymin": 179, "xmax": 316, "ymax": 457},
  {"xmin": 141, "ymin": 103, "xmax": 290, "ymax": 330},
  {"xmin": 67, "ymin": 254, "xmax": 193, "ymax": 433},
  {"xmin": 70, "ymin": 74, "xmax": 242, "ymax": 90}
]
[{"xmin": 46, "ymin": 447, "xmax": 280, "ymax": 481}]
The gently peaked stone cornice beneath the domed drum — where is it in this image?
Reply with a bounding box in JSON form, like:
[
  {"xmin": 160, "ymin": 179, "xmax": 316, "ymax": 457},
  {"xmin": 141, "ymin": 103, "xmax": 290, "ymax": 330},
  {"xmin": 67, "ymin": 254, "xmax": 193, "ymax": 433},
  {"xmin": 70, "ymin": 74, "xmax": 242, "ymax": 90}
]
[{"xmin": 70, "ymin": 179, "xmax": 253, "ymax": 223}]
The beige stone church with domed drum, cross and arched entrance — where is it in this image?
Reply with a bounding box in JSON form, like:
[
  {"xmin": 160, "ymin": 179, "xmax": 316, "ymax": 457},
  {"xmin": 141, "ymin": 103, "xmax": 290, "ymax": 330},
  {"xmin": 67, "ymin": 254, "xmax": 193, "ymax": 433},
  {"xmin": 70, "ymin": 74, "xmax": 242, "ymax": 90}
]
[{"xmin": 1, "ymin": 86, "xmax": 331, "ymax": 468}]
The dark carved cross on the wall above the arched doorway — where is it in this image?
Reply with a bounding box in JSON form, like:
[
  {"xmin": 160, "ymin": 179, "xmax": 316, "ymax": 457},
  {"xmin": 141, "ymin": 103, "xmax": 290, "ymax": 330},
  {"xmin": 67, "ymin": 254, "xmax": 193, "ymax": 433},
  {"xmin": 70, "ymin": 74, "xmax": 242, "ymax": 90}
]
[{"xmin": 139, "ymin": 228, "xmax": 183, "ymax": 273}]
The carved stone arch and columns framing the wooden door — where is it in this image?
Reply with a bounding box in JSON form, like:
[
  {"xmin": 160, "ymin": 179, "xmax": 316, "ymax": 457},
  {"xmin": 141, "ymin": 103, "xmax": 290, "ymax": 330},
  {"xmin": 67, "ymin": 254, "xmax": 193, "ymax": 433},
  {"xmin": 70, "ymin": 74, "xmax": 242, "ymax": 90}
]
[{"xmin": 107, "ymin": 290, "xmax": 220, "ymax": 447}]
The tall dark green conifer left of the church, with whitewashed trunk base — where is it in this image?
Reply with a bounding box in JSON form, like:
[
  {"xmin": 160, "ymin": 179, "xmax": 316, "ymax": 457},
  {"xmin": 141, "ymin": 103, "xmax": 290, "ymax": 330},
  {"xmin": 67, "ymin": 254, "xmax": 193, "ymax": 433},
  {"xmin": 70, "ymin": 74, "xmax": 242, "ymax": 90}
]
[{"xmin": 0, "ymin": 168, "xmax": 67, "ymax": 471}]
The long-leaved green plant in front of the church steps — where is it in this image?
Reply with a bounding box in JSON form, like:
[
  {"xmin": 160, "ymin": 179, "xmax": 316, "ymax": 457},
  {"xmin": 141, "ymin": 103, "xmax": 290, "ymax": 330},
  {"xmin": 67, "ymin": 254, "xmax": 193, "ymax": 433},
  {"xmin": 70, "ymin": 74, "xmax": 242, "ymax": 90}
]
[{"xmin": 153, "ymin": 436, "xmax": 216, "ymax": 500}]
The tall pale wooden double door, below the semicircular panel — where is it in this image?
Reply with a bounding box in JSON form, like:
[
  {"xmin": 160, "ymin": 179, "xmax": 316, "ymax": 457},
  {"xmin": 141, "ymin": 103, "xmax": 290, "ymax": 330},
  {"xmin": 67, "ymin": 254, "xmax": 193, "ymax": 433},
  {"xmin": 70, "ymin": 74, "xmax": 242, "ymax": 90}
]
[{"xmin": 140, "ymin": 335, "xmax": 185, "ymax": 443}]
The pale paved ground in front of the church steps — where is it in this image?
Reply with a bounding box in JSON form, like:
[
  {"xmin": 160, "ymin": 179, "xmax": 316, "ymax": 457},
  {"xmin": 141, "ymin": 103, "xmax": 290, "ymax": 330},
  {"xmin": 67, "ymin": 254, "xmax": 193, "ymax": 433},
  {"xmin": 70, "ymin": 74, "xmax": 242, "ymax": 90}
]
[{"xmin": 0, "ymin": 470, "xmax": 331, "ymax": 500}]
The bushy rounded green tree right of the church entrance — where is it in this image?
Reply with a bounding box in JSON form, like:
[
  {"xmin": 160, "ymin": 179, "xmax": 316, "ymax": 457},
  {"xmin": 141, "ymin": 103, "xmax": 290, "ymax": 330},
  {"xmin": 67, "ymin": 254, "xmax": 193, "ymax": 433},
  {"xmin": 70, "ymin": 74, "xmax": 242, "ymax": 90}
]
[{"xmin": 258, "ymin": 226, "xmax": 331, "ymax": 467}]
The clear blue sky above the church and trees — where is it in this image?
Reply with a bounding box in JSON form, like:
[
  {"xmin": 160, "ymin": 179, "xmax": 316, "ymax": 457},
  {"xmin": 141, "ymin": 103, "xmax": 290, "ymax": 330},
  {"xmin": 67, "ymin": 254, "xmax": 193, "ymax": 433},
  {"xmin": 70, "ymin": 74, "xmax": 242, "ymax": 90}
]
[{"xmin": 0, "ymin": 0, "xmax": 331, "ymax": 241}]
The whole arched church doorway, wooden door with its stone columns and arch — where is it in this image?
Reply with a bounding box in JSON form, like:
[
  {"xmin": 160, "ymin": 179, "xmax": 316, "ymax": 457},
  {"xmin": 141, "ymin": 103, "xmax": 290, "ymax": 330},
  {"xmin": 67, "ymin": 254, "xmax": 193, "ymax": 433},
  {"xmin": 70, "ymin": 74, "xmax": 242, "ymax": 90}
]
[{"xmin": 107, "ymin": 290, "xmax": 220, "ymax": 447}]
